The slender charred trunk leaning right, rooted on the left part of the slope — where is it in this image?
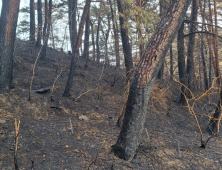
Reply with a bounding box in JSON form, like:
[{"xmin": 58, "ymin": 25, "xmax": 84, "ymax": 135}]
[{"xmin": 63, "ymin": 0, "xmax": 91, "ymax": 97}]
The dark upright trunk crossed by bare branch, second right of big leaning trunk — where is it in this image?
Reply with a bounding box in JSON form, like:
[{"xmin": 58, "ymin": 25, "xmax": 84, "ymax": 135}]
[{"xmin": 187, "ymin": 0, "xmax": 198, "ymax": 95}]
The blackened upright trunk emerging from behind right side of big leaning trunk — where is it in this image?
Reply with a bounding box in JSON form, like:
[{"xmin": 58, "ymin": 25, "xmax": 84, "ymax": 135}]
[{"xmin": 177, "ymin": 22, "xmax": 186, "ymax": 105}]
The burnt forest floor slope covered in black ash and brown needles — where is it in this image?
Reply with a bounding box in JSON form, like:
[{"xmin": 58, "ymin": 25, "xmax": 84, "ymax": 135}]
[{"xmin": 0, "ymin": 40, "xmax": 222, "ymax": 170}]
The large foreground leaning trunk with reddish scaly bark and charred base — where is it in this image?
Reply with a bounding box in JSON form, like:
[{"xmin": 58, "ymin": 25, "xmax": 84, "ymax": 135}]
[{"xmin": 112, "ymin": 0, "xmax": 191, "ymax": 160}]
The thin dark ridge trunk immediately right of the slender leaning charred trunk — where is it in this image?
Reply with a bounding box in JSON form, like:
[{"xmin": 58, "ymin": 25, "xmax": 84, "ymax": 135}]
[{"xmin": 83, "ymin": 11, "xmax": 90, "ymax": 67}]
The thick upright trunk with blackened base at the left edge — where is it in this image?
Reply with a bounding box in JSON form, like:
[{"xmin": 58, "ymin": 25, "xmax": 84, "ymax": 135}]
[{"xmin": 0, "ymin": 0, "xmax": 20, "ymax": 89}]
